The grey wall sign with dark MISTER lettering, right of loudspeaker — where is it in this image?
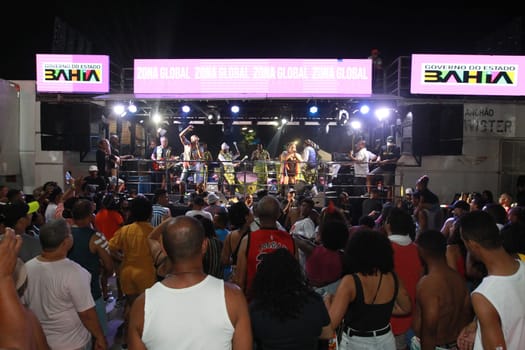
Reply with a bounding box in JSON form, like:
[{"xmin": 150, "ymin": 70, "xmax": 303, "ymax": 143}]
[{"xmin": 463, "ymin": 104, "xmax": 516, "ymax": 137}]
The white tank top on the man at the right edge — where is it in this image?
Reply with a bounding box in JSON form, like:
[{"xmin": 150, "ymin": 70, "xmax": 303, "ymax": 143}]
[{"xmin": 472, "ymin": 261, "xmax": 525, "ymax": 350}]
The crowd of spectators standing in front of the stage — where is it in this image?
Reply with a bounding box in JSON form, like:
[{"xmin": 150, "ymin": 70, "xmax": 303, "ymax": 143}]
[{"xmin": 0, "ymin": 169, "xmax": 525, "ymax": 350}]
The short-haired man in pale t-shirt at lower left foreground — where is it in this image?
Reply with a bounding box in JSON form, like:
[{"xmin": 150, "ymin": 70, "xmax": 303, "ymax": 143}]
[{"xmin": 22, "ymin": 219, "xmax": 108, "ymax": 349}]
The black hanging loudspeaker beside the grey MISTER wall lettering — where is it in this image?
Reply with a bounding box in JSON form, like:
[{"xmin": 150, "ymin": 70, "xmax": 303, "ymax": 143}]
[{"xmin": 405, "ymin": 104, "xmax": 463, "ymax": 156}]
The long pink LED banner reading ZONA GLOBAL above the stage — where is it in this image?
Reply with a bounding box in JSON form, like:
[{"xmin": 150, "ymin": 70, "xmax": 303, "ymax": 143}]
[{"xmin": 133, "ymin": 59, "xmax": 372, "ymax": 98}]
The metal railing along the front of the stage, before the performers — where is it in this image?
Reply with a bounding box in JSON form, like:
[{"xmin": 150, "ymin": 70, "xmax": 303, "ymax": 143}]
[{"xmin": 119, "ymin": 158, "xmax": 397, "ymax": 201}]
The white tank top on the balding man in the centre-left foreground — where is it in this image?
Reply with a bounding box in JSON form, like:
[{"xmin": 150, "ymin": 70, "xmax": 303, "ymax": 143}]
[{"xmin": 142, "ymin": 276, "xmax": 235, "ymax": 350}]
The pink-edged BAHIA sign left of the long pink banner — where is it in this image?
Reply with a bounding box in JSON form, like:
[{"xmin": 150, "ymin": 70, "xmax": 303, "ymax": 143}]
[{"xmin": 36, "ymin": 54, "xmax": 109, "ymax": 93}]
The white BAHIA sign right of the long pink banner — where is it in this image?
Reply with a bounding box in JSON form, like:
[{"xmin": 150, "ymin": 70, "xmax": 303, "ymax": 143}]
[{"xmin": 410, "ymin": 54, "xmax": 525, "ymax": 96}]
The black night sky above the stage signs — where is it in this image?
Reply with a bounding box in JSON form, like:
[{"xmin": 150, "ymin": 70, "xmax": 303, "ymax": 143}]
[{"xmin": 0, "ymin": 1, "xmax": 519, "ymax": 80}]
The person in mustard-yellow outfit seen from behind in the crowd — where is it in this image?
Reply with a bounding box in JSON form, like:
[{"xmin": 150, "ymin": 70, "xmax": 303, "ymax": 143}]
[{"xmin": 109, "ymin": 196, "xmax": 157, "ymax": 348}]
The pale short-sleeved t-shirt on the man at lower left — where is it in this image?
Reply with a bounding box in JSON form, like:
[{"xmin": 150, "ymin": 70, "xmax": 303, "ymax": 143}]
[{"xmin": 22, "ymin": 257, "xmax": 95, "ymax": 350}]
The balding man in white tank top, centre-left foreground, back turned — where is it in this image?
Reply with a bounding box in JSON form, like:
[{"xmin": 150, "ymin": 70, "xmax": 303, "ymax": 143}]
[{"xmin": 128, "ymin": 216, "xmax": 253, "ymax": 350}]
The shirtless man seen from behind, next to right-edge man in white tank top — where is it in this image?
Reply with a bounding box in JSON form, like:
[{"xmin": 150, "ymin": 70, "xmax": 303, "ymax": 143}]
[{"xmin": 412, "ymin": 230, "xmax": 473, "ymax": 349}]
